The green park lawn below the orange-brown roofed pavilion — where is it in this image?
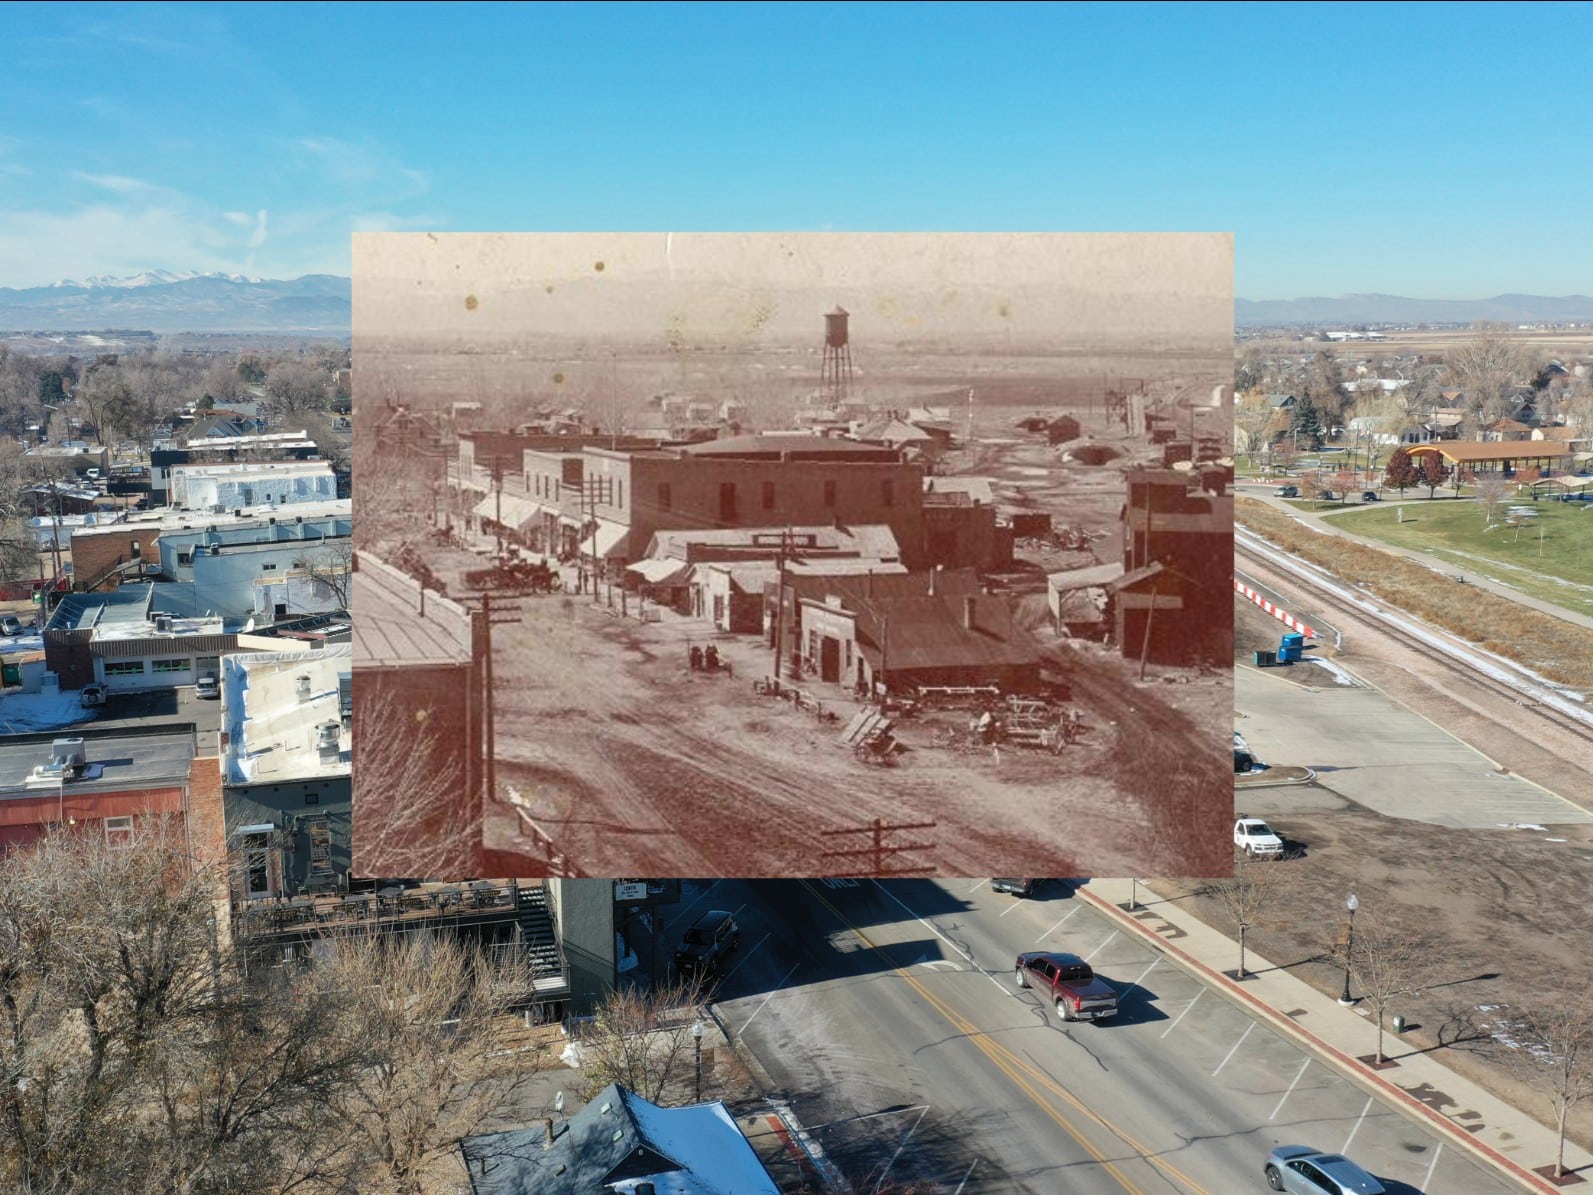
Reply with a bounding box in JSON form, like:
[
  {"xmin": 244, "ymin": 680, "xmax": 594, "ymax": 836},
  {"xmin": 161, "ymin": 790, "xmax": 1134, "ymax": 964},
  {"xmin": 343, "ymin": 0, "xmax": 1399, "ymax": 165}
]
[{"xmin": 1301, "ymin": 500, "xmax": 1593, "ymax": 613}]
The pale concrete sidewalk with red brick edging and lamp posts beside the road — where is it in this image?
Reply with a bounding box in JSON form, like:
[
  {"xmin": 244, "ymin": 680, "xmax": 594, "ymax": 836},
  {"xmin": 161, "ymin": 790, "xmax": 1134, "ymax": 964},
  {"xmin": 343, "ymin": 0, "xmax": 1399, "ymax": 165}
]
[{"xmin": 1078, "ymin": 880, "xmax": 1593, "ymax": 1192}]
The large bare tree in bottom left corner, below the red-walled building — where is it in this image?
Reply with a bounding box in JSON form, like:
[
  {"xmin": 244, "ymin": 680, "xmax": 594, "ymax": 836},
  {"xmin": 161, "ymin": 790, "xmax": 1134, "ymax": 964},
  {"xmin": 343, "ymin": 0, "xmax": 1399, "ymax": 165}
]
[{"xmin": 0, "ymin": 825, "xmax": 226, "ymax": 1192}]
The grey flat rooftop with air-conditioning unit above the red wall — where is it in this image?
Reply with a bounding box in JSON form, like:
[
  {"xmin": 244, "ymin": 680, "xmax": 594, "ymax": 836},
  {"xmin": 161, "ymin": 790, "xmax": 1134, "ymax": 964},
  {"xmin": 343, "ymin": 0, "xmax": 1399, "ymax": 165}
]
[{"xmin": 0, "ymin": 722, "xmax": 194, "ymax": 800}]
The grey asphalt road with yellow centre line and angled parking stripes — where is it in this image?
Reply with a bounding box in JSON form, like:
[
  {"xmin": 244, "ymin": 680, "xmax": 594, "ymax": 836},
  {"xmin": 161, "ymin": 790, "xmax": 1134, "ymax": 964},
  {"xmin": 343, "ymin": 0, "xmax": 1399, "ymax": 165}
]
[{"xmin": 700, "ymin": 880, "xmax": 1517, "ymax": 1195}]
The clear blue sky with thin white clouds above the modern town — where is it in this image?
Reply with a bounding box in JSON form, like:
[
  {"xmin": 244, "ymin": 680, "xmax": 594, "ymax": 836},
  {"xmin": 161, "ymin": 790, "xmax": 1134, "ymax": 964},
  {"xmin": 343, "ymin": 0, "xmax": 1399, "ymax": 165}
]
[{"xmin": 0, "ymin": 3, "xmax": 1593, "ymax": 298}]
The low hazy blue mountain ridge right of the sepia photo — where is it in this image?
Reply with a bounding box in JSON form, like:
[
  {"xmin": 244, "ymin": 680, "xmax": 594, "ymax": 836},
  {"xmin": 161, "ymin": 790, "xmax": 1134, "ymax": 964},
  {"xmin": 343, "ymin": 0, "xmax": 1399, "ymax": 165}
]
[{"xmin": 1233, "ymin": 295, "xmax": 1593, "ymax": 327}]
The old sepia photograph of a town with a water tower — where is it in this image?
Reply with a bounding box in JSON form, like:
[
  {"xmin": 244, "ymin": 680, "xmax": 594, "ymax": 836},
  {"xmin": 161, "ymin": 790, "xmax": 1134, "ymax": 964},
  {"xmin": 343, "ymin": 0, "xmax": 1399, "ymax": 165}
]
[{"xmin": 352, "ymin": 233, "xmax": 1233, "ymax": 876}]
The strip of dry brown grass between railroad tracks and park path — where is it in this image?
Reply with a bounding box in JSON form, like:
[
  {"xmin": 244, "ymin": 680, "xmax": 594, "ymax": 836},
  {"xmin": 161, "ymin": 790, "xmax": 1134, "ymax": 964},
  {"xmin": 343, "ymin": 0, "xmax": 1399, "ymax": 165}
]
[{"xmin": 1235, "ymin": 497, "xmax": 1593, "ymax": 692}]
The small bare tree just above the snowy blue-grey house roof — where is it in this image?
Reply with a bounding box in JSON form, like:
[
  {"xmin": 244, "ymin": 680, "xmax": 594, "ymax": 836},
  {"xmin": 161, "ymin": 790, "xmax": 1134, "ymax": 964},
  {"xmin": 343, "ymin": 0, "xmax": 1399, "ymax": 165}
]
[{"xmin": 580, "ymin": 974, "xmax": 710, "ymax": 1104}]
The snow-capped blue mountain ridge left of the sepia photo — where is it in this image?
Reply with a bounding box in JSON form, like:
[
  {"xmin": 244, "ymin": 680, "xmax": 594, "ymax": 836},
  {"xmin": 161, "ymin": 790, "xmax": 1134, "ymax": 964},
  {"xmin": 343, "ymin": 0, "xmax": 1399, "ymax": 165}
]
[{"xmin": 0, "ymin": 269, "xmax": 354, "ymax": 336}]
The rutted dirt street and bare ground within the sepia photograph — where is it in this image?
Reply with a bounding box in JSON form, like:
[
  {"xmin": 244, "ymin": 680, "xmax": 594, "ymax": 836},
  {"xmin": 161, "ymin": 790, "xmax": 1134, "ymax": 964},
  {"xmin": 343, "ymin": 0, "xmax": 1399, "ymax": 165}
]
[{"xmin": 395, "ymin": 408, "xmax": 1233, "ymax": 876}]
